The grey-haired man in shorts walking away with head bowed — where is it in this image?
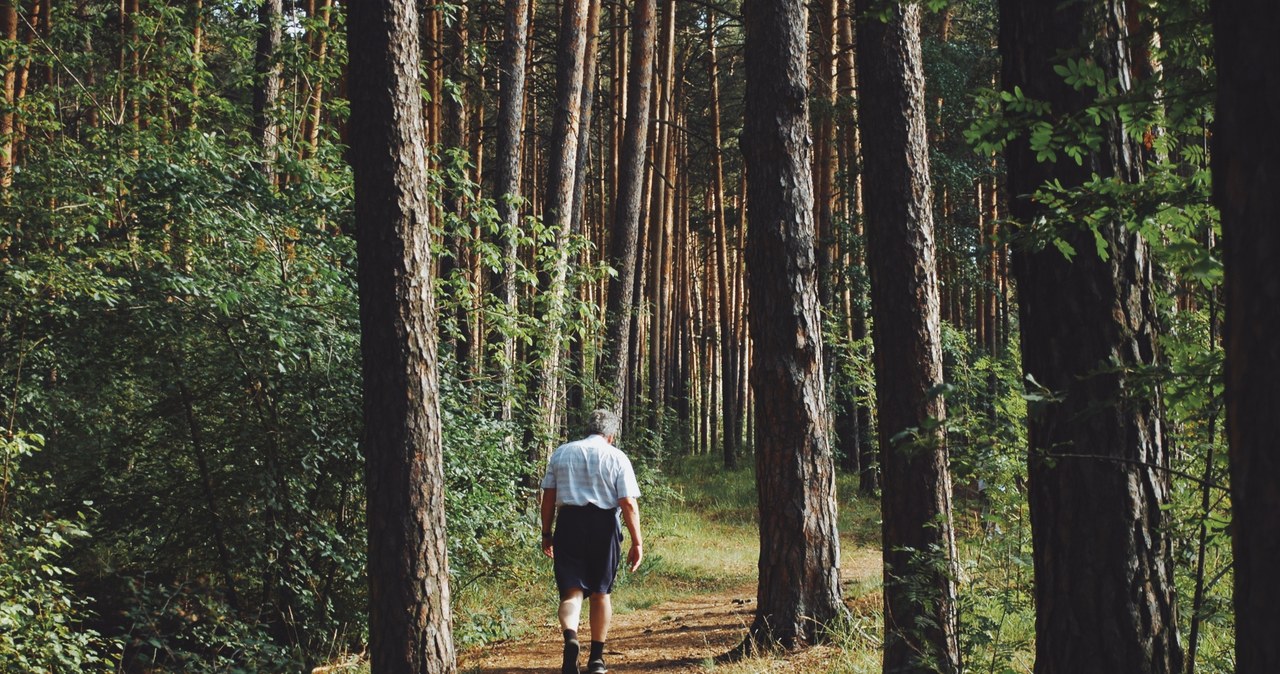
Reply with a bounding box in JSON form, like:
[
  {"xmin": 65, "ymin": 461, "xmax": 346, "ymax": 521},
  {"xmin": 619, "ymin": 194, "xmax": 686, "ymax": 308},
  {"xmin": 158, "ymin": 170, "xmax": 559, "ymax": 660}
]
[{"xmin": 541, "ymin": 409, "xmax": 644, "ymax": 674}]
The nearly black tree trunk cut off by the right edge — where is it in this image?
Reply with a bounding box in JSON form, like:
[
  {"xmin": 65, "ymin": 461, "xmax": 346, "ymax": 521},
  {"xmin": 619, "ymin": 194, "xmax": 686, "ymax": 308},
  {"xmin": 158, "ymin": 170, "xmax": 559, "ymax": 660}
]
[{"xmin": 1211, "ymin": 0, "xmax": 1280, "ymax": 674}]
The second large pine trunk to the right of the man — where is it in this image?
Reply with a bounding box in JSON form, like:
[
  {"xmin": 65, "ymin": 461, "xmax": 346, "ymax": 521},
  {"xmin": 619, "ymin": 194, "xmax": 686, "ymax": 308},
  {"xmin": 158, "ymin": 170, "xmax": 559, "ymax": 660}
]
[{"xmin": 858, "ymin": 4, "xmax": 960, "ymax": 674}]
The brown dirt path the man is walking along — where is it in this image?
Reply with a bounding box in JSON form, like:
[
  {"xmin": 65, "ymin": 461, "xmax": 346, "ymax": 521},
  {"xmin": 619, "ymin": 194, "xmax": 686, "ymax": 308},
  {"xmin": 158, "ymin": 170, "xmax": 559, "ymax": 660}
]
[{"xmin": 458, "ymin": 541, "xmax": 881, "ymax": 674}]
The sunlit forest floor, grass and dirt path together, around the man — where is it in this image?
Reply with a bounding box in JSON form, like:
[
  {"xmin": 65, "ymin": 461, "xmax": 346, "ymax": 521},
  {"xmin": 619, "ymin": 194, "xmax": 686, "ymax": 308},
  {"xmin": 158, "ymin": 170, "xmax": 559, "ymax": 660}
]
[{"xmin": 458, "ymin": 458, "xmax": 881, "ymax": 674}]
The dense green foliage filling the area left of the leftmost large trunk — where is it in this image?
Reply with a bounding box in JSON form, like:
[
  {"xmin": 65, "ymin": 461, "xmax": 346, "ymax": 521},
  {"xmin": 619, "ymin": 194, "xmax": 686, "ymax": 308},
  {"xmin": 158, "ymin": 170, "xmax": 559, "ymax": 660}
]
[{"xmin": 0, "ymin": 0, "xmax": 365, "ymax": 671}]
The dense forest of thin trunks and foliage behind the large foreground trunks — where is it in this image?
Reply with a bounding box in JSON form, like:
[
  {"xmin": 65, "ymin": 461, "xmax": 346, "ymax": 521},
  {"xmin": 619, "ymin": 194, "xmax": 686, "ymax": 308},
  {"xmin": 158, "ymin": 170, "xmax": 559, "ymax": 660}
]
[{"xmin": 0, "ymin": 0, "xmax": 1263, "ymax": 671}]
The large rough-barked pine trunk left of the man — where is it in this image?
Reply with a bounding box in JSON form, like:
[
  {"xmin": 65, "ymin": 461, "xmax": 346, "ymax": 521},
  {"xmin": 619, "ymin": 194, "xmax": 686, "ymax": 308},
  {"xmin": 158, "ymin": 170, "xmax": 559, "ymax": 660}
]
[{"xmin": 347, "ymin": 0, "xmax": 456, "ymax": 674}]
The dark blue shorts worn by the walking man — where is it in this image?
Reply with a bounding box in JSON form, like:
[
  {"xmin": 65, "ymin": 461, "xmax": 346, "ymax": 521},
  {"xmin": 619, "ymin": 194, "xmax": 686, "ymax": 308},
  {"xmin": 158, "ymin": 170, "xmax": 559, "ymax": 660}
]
[{"xmin": 552, "ymin": 505, "xmax": 622, "ymax": 596}]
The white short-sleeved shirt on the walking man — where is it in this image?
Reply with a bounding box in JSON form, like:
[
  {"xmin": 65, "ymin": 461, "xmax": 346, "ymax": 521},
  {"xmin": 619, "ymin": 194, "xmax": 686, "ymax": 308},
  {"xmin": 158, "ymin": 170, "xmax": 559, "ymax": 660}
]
[{"xmin": 541, "ymin": 435, "xmax": 640, "ymax": 509}]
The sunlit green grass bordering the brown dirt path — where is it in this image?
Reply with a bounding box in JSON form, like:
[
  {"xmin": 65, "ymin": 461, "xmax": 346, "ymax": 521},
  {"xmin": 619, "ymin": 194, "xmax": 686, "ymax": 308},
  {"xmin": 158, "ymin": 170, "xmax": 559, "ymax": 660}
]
[{"xmin": 345, "ymin": 457, "xmax": 896, "ymax": 674}]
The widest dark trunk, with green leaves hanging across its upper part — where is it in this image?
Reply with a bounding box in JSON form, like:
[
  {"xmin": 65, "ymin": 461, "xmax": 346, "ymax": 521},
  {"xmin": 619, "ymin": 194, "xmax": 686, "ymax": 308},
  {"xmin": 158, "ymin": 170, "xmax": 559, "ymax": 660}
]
[{"xmin": 1000, "ymin": 0, "xmax": 1183, "ymax": 674}]
